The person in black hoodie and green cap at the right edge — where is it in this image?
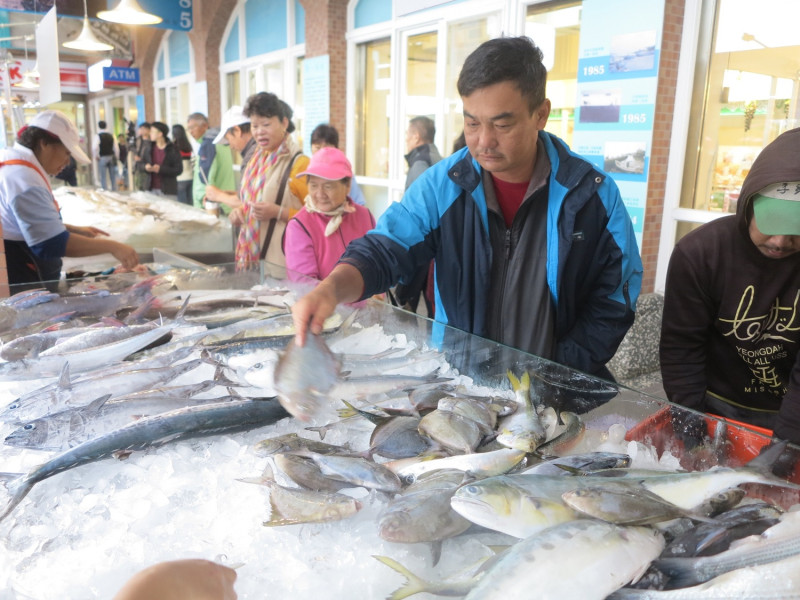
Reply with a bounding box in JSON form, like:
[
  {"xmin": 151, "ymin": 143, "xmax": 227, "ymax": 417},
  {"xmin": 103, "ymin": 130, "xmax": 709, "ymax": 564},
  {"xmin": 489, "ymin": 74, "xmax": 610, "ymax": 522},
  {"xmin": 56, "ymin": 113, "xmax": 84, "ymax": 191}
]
[{"xmin": 660, "ymin": 129, "xmax": 800, "ymax": 446}]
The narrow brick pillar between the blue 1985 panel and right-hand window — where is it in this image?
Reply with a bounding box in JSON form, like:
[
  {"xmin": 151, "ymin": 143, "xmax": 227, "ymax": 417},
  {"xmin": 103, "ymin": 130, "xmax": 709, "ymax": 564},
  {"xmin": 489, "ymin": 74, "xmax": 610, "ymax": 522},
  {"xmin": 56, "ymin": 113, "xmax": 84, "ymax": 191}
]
[{"xmin": 640, "ymin": 0, "xmax": 685, "ymax": 293}]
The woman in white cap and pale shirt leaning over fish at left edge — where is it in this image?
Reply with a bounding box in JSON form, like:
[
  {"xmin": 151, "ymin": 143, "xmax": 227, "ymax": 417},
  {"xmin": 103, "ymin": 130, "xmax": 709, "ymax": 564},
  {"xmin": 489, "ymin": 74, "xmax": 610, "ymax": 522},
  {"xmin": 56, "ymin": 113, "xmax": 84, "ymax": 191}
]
[{"xmin": 0, "ymin": 110, "xmax": 139, "ymax": 285}]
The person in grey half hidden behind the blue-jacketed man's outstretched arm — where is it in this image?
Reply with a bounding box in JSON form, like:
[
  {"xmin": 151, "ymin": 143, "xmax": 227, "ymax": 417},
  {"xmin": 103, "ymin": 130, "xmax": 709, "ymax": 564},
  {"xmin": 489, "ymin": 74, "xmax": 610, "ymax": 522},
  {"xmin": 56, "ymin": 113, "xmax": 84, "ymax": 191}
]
[{"xmin": 394, "ymin": 116, "xmax": 442, "ymax": 316}]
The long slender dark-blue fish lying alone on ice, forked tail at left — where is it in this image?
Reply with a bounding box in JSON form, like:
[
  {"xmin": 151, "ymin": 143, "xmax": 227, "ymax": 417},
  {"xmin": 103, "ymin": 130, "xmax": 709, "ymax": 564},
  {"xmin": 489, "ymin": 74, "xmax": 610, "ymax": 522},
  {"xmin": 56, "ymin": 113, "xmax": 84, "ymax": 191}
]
[{"xmin": 0, "ymin": 400, "xmax": 288, "ymax": 521}]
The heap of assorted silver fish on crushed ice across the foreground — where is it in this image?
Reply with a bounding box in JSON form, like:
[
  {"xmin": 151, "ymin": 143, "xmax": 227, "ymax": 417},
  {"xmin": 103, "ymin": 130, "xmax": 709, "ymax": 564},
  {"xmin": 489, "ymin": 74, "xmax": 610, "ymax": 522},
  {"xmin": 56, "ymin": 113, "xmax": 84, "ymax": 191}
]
[{"xmin": 0, "ymin": 279, "xmax": 800, "ymax": 598}]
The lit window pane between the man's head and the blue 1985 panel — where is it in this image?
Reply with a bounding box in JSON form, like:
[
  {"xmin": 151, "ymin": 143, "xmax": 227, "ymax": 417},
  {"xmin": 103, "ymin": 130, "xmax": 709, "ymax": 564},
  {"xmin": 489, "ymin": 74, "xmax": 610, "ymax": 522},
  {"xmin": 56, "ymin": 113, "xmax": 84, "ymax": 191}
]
[{"xmin": 525, "ymin": 2, "xmax": 581, "ymax": 145}]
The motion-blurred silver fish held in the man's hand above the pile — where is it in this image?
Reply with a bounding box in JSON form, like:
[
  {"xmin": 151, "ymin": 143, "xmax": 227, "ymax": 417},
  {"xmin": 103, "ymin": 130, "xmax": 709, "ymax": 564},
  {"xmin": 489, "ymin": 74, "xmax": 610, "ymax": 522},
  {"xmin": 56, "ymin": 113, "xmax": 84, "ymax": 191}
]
[{"xmin": 274, "ymin": 333, "xmax": 342, "ymax": 421}]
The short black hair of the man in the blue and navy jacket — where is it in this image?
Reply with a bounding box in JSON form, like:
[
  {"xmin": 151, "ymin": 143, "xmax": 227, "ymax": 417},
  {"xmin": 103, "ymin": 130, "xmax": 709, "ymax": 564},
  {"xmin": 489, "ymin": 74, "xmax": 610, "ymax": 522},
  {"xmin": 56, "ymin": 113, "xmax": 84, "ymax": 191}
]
[{"xmin": 458, "ymin": 36, "xmax": 547, "ymax": 114}]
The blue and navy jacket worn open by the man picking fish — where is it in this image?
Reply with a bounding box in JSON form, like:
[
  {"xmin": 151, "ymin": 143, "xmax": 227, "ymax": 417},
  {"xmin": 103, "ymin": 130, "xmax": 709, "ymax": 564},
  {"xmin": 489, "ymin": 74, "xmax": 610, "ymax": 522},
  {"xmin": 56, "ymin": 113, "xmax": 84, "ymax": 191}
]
[{"xmin": 341, "ymin": 132, "xmax": 642, "ymax": 377}]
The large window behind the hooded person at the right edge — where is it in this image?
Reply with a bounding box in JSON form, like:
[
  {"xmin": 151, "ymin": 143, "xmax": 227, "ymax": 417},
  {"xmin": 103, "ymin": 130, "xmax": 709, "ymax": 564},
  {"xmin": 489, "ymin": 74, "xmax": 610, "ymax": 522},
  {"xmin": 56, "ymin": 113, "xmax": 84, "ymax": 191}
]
[{"xmin": 678, "ymin": 0, "xmax": 800, "ymax": 216}]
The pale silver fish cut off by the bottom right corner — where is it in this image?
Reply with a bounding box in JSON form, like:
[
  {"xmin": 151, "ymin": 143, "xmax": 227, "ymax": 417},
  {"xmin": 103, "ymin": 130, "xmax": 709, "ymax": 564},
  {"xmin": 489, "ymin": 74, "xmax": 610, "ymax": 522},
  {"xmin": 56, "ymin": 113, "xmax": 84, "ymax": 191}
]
[{"xmin": 608, "ymin": 556, "xmax": 800, "ymax": 600}]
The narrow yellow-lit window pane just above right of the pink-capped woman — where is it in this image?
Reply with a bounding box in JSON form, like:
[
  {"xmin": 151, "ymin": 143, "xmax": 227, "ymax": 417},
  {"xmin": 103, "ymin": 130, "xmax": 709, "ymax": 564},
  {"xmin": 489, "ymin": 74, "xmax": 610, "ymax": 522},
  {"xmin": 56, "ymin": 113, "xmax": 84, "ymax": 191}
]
[{"xmin": 355, "ymin": 38, "xmax": 392, "ymax": 178}]
